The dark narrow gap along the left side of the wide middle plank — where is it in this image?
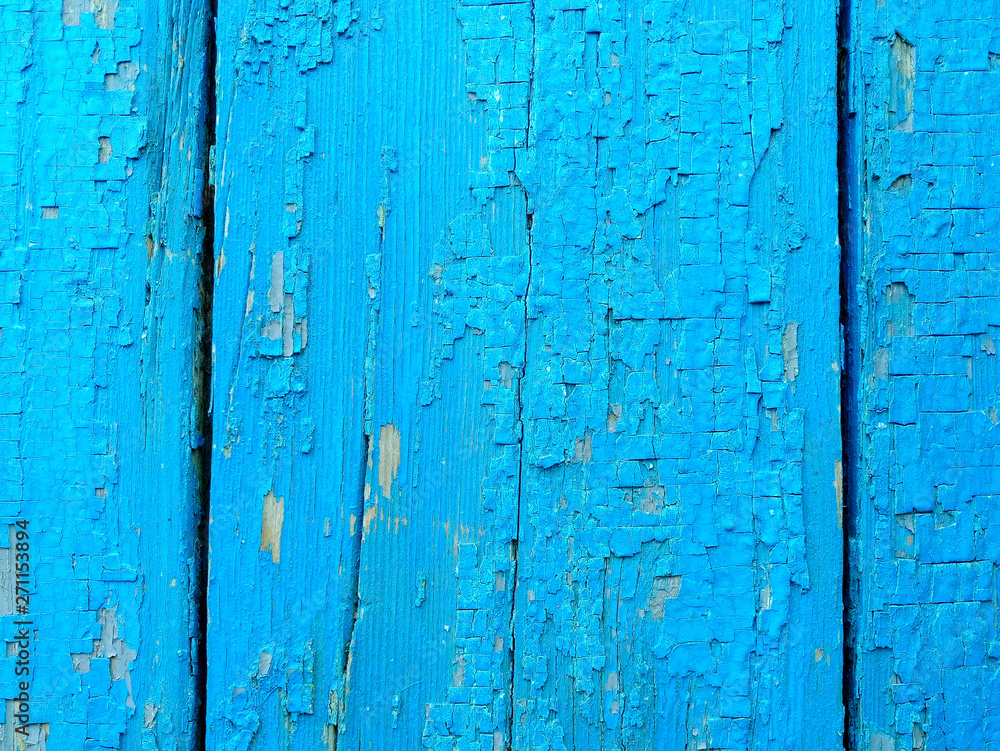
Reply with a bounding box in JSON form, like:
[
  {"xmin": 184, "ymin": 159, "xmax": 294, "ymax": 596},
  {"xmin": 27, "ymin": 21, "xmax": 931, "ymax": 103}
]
[{"xmin": 192, "ymin": 0, "xmax": 218, "ymax": 750}]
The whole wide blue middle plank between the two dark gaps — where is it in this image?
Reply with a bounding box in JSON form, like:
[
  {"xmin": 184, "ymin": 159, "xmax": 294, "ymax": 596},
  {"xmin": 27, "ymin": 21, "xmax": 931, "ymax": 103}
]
[{"xmin": 209, "ymin": 0, "xmax": 842, "ymax": 749}]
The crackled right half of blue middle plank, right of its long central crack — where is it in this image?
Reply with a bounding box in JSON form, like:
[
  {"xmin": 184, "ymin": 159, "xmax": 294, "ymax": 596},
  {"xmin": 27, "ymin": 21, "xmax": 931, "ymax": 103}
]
[{"xmin": 512, "ymin": 0, "xmax": 842, "ymax": 749}]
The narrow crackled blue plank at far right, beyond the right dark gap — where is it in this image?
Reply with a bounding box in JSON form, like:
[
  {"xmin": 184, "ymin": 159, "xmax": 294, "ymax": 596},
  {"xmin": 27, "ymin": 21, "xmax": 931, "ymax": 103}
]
[{"xmin": 846, "ymin": 0, "xmax": 1000, "ymax": 750}]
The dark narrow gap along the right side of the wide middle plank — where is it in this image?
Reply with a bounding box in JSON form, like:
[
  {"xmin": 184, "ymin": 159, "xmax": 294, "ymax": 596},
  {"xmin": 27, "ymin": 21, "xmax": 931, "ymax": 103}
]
[{"xmin": 837, "ymin": 0, "xmax": 861, "ymax": 751}]
